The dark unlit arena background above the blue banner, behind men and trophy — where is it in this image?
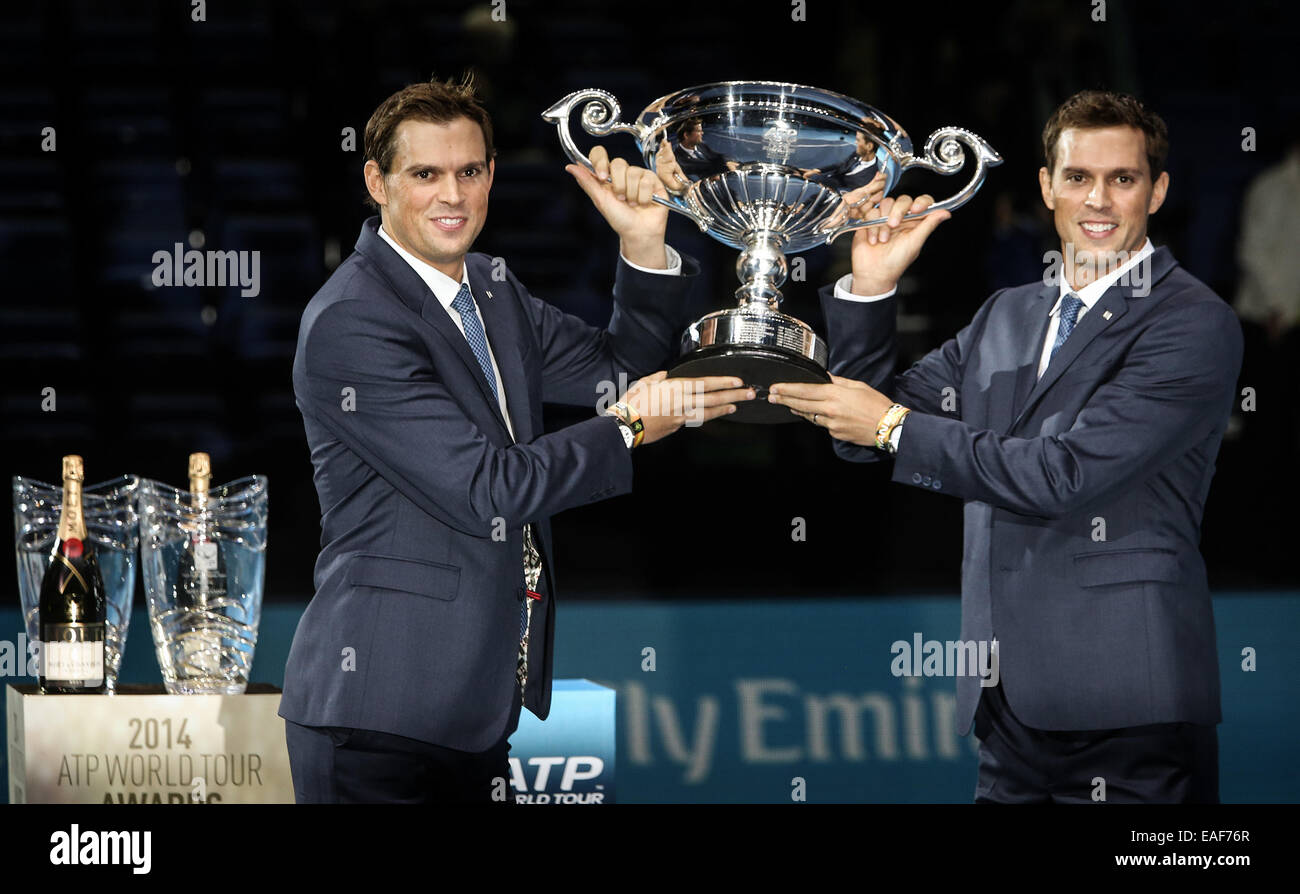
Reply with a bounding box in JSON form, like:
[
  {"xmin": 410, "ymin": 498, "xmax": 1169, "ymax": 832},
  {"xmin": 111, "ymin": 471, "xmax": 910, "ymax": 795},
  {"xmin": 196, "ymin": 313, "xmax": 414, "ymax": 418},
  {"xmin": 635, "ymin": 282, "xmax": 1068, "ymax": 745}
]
[{"xmin": 0, "ymin": 0, "xmax": 1300, "ymax": 600}]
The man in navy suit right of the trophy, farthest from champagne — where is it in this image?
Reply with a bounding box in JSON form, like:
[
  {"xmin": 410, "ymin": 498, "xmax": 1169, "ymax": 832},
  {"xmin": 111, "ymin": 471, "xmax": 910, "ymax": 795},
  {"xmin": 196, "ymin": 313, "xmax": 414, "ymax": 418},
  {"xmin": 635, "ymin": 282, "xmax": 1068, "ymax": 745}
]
[{"xmin": 771, "ymin": 91, "xmax": 1242, "ymax": 802}]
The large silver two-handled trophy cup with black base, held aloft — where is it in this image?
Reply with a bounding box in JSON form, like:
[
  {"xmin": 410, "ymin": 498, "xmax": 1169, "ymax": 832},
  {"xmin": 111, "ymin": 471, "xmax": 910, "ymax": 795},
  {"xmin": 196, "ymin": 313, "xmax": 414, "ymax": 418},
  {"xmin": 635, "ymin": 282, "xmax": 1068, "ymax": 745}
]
[{"xmin": 542, "ymin": 81, "xmax": 1002, "ymax": 422}]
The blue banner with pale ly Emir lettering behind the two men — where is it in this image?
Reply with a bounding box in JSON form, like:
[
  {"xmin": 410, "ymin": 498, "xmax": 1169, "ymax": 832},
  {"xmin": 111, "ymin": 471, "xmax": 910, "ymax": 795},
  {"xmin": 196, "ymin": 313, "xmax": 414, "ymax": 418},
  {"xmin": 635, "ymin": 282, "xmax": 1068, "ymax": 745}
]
[{"xmin": 0, "ymin": 593, "xmax": 1300, "ymax": 803}]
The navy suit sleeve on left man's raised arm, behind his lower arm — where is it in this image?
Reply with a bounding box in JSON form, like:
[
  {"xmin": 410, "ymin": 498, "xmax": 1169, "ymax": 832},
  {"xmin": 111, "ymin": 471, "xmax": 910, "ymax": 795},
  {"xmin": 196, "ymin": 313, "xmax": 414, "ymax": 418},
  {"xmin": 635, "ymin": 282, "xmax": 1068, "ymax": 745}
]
[{"xmin": 511, "ymin": 255, "xmax": 699, "ymax": 407}]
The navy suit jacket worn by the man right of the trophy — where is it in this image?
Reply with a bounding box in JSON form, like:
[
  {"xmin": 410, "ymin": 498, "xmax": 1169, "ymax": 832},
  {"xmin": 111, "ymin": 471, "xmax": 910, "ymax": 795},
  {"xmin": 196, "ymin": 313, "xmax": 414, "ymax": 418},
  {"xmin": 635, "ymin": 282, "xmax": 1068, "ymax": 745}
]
[{"xmin": 822, "ymin": 248, "xmax": 1242, "ymax": 734}]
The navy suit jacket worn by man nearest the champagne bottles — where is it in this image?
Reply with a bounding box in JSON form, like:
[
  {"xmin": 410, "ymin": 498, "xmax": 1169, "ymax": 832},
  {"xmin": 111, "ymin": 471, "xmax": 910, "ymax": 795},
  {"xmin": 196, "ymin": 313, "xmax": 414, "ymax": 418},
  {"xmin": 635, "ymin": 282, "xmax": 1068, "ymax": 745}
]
[{"xmin": 280, "ymin": 217, "xmax": 696, "ymax": 751}]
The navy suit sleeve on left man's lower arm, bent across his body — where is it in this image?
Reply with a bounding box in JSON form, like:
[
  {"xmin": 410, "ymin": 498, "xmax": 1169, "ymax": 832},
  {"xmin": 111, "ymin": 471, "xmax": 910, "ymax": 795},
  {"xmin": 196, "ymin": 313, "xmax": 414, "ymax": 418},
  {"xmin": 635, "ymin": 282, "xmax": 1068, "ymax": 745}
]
[{"xmin": 294, "ymin": 285, "xmax": 632, "ymax": 537}]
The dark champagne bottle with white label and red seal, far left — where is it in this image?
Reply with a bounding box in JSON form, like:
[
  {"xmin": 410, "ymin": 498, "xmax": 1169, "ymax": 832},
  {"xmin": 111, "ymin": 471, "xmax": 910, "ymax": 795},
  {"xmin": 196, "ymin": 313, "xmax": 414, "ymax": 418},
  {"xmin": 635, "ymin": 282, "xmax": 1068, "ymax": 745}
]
[{"xmin": 39, "ymin": 456, "xmax": 108, "ymax": 695}]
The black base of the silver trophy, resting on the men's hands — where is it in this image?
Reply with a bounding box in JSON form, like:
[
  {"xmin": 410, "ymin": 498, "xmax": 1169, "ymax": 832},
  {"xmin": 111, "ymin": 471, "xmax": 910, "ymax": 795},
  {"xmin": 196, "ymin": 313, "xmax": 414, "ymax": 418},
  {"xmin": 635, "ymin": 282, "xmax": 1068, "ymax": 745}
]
[{"xmin": 668, "ymin": 346, "xmax": 831, "ymax": 425}]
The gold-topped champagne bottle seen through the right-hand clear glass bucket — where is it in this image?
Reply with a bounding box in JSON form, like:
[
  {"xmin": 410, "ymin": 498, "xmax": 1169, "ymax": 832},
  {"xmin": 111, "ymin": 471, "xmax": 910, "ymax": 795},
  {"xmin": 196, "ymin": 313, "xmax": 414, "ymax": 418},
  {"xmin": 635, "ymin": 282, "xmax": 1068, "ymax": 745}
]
[{"xmin": 176, "ymin": 453, "xmax": 226, "ymax": 677}]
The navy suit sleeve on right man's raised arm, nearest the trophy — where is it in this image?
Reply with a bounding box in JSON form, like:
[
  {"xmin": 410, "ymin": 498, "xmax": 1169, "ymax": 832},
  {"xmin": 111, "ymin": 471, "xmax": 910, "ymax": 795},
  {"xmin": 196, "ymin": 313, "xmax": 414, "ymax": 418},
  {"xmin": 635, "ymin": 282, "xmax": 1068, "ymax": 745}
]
[{"xmin": 822, "ymin": 286, "xmax": 1001, "ymax": 463}]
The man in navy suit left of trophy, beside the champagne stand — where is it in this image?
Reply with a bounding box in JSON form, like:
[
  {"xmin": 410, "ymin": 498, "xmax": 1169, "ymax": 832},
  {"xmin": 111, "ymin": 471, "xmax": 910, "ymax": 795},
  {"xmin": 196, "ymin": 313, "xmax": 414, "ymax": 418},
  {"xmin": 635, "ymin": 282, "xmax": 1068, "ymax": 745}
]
[{"xmin": 280, "ymin": 82, "xmax": 753, "ymax": 803}]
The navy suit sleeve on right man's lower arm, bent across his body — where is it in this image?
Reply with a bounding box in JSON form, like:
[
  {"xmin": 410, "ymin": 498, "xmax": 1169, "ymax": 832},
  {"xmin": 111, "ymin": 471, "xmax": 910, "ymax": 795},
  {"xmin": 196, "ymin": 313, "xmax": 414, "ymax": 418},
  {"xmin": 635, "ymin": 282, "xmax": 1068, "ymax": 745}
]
[{"xmin": 893, "ymin": 298, "xmax": 1243, "ymax": 518}]
